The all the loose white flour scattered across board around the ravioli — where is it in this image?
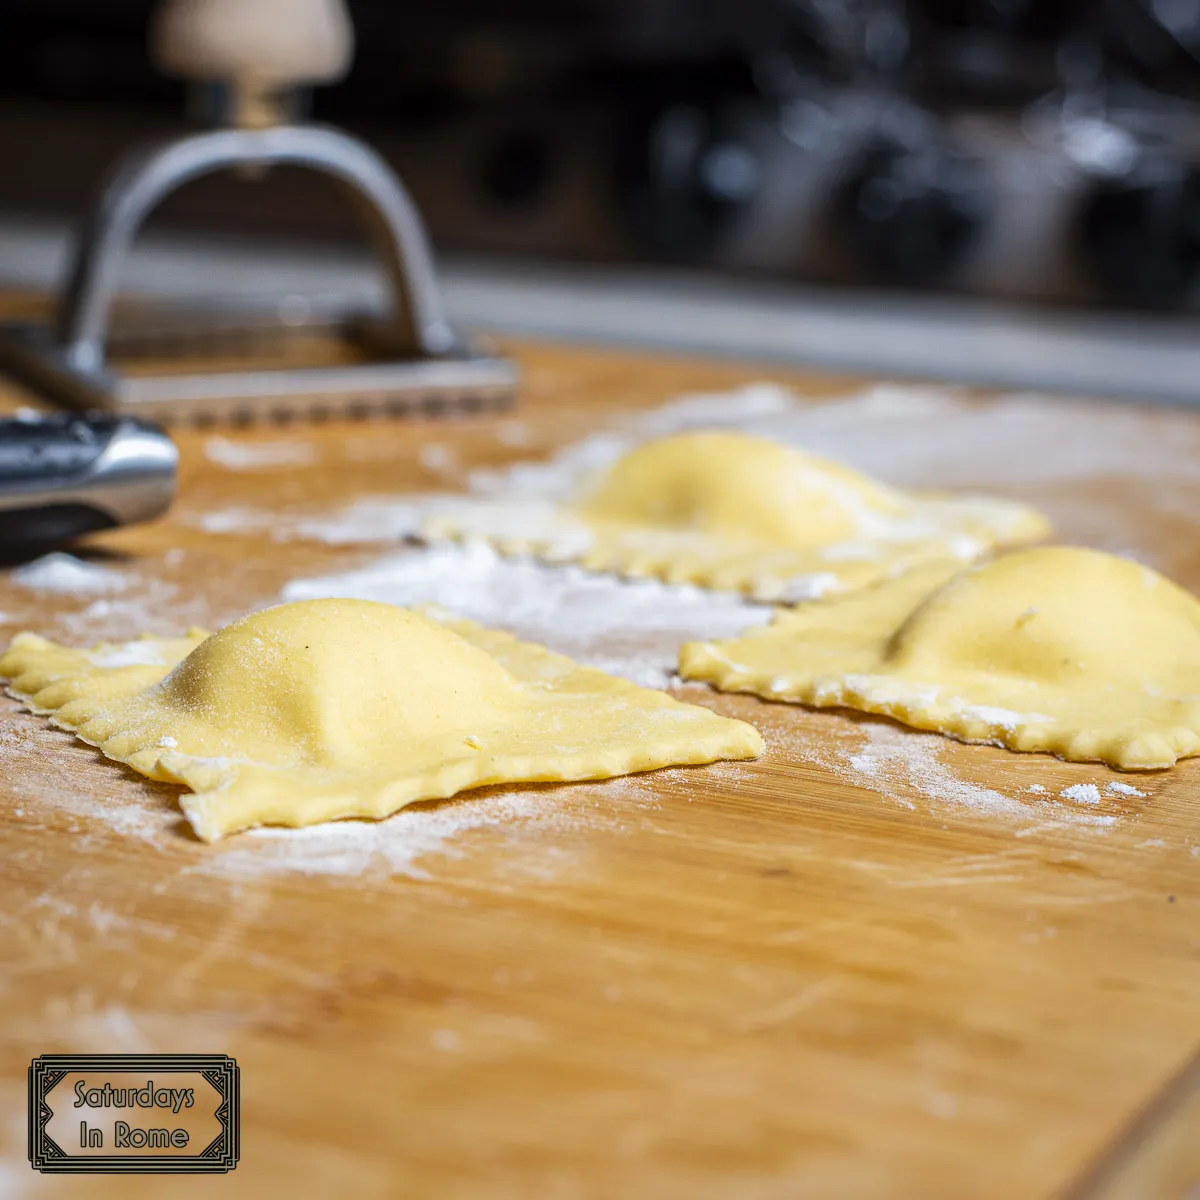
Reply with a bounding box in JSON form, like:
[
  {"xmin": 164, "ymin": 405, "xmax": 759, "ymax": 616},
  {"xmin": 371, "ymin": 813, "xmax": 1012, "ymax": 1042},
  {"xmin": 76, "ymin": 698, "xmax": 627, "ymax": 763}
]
[{"xmin": 11, "ymin": 384, "xmax": 1180, "ymax": 875}]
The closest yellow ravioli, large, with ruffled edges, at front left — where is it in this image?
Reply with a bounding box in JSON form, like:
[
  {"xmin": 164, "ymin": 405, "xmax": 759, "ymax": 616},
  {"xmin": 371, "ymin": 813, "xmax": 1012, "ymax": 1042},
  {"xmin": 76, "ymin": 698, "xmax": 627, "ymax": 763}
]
[{"xmin": 0, "ymin": 600, "xmax": 762, "ymax": 841}]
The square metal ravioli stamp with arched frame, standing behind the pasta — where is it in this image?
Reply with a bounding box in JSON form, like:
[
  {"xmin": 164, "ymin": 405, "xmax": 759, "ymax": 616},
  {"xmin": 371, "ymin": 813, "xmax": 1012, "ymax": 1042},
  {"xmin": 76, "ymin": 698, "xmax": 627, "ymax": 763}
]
[{"xmin": 0, "ymin": 0, "xmax": 516, "ymax": 424}]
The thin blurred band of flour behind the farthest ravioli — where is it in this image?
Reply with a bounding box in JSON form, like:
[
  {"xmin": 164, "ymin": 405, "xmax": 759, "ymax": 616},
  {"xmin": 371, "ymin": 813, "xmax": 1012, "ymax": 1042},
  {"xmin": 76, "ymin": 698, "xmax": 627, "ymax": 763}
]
[{"xmin": 182, "ymin": 383, "xmax": 1200, "ymax": 550}]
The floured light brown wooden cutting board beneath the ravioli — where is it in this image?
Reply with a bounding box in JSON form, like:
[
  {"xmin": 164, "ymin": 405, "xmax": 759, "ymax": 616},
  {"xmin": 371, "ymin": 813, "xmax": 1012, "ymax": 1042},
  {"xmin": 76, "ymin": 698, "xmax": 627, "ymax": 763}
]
[{"xmin": 0, "ymin": 324, "xmax": 1200, "ymax": 1200}]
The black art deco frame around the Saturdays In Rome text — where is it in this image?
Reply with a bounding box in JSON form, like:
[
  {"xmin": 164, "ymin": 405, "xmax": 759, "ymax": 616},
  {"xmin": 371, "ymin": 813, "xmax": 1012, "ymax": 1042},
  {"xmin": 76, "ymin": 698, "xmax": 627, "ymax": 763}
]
[{"xmin": 29, "ymin": 1054, "xmax": 241, "ymax": 1175}]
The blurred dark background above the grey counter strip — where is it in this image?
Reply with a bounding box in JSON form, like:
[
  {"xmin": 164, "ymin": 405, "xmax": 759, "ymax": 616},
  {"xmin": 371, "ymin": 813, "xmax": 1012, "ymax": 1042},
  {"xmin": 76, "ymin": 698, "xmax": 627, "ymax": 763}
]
[{"xmin": 0, "ymin": 0, "xmax": 1200, "ymax": 311}]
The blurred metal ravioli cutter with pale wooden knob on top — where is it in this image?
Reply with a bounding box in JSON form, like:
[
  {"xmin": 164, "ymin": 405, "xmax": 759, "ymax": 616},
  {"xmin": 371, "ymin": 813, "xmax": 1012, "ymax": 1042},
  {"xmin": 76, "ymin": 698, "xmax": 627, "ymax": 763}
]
[{"xmin": 0, "ymin": 0, "xmax": 516, "ymax": 422}]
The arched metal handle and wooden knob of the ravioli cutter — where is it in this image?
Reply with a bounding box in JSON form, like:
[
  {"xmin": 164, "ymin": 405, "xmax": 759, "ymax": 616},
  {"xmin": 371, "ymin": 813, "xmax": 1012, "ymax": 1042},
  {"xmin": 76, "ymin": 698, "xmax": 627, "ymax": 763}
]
[{"xmin": 53, "ymin": 0, "xmax": 455, "ymax": 379}]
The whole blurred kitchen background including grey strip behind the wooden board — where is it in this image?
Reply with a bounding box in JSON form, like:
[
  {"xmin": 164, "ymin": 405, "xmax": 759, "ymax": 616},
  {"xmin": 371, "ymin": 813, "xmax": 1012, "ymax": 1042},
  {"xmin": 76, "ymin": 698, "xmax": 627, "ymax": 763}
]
[{"xmin": 0, "ymin": 0, "xmax": 1200, "ymax": 402}]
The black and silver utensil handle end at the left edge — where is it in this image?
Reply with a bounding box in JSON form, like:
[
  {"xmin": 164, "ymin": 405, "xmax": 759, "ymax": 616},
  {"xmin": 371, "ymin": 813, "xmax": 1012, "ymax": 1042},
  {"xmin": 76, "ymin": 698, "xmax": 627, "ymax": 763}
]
[{"xmin": 0, "ymin": 414, "xmax": 179, "ymax": 554}]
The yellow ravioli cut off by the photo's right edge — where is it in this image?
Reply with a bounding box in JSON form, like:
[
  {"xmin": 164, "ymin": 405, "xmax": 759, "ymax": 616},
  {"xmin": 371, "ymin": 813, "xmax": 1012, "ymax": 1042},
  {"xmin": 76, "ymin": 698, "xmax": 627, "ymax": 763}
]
[{"xmin": 679, "ymin": 546, "xmax": 1200, "ymax": 770}]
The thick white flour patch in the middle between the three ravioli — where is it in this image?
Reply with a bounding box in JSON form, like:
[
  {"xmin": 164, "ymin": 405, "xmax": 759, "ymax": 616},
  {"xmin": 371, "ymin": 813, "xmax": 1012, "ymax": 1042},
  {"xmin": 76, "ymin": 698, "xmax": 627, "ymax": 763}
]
[{"xmin": 281, "ymin": 544, "xmax": 770, "ymax": 688}]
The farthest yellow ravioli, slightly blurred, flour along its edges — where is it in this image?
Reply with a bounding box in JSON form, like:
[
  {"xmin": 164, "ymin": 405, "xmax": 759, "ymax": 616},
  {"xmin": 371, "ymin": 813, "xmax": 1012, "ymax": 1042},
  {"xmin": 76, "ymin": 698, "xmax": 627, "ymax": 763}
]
[{"xmin": 424, "ymin": 431, "xmax": 1049, "ymax": 602}]
